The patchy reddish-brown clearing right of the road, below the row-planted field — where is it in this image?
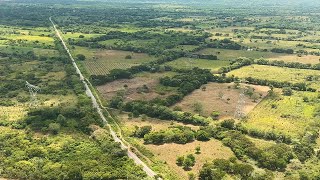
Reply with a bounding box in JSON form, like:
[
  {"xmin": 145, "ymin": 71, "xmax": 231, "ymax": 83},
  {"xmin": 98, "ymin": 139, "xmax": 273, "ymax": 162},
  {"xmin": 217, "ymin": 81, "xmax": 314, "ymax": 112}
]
[{"xmin": 97, "ymin": 73, "xmax": 175, "ymax": 101}]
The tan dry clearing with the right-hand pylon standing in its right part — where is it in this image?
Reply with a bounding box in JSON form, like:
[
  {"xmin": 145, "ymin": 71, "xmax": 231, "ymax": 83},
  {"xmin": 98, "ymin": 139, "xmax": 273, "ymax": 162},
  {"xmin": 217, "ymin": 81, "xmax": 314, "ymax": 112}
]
[{"xmin": 173, "ymin": 83, "xmax": 269, "ymax": 119}]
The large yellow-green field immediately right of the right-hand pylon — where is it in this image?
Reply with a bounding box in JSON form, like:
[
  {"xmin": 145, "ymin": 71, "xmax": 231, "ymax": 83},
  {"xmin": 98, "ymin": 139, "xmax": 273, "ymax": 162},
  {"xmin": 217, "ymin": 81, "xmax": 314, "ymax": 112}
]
[{"xmin": 244, "ymin": 92, "xmax": 317, "ymax": 137}]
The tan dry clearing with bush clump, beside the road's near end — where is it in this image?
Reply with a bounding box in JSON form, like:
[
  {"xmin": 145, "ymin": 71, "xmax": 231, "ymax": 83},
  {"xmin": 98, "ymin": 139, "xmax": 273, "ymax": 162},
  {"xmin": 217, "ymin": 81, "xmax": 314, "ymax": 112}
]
[{"xmin": 145, "ymin": 139, "xmax": 234, "ymax": 179}]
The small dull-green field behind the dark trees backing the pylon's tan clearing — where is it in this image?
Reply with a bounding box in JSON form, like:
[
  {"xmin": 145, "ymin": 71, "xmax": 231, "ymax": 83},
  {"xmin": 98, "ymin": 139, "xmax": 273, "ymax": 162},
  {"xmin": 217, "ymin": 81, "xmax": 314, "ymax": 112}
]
[{"xmin": 165, "ymin": 58, "xmax": 230, "ymax": 72}]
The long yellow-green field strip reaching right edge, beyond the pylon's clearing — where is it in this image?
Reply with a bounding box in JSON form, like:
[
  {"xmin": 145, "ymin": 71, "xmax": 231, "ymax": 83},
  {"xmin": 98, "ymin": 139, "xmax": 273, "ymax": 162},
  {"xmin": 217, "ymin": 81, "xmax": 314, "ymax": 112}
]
[{"xmin": 228, "ymin": 65, "xmax": 320, "ymax": 89}]
